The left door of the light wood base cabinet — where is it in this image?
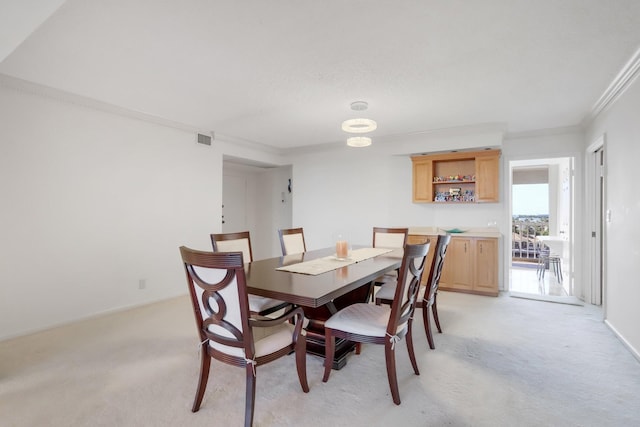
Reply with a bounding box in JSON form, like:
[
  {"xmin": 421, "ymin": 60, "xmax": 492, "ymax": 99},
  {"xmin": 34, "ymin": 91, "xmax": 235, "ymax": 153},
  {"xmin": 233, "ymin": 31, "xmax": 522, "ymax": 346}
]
[{"xmin": 440, "ymin": 237, "xmax": 473, "ymax": 290}]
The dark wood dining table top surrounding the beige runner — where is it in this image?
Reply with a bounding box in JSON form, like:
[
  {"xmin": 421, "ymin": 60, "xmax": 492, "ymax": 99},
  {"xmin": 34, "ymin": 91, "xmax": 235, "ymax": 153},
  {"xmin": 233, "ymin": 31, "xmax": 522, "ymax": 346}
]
[{"xmin": 245, "ymin": 248, "xmax": 403, "ymax": 307}]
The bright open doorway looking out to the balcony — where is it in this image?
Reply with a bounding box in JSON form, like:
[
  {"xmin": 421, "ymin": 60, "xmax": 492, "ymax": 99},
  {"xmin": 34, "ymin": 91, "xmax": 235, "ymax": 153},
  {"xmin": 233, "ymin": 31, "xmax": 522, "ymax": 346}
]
[{"xmin": 509, "ymin": 157, "xmax": 575, "ymax": 300}]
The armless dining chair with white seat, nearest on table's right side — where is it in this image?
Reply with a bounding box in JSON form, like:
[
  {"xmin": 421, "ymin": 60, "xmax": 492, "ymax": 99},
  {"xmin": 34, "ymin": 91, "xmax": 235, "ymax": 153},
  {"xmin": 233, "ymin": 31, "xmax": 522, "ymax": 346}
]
[{"xmin": 322, "ymin": 243, "xmax": 429, "ymax": 405}]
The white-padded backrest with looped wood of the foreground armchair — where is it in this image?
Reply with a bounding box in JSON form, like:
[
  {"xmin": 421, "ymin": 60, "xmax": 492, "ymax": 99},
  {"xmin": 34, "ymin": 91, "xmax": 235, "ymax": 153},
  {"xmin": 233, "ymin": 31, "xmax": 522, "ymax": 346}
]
[{"xmin": 180, "ymin": 246, "xmax": 255, "ymax": 364}]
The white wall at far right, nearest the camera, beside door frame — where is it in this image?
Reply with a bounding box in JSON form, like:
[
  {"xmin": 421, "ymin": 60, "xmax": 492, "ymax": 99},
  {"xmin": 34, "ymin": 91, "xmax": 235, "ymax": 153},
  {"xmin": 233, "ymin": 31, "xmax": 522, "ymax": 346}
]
[{"xmin": 586, "ymin": 80, "xmax": 640, "ymax": 357}]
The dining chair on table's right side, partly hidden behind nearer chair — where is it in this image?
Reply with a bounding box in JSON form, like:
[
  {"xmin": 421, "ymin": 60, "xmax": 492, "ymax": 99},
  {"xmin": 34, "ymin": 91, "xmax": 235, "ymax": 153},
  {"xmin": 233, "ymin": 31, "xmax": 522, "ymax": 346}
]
[{"xmin": 375, "ymin": 235, "xmax": 451, "ymax": 350}]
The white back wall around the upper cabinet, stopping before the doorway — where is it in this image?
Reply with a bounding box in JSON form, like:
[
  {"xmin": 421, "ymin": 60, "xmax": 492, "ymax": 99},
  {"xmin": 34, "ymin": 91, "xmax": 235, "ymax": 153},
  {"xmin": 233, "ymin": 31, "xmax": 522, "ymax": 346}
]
[{"xmin": 291, "ymin": 129, "xmax": 508, "ymax": 284}]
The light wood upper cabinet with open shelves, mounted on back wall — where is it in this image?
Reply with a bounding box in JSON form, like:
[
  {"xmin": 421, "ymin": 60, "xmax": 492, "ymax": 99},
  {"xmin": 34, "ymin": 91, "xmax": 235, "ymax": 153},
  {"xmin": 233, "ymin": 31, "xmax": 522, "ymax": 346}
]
[{"xmin": 411, "ymin": 150, "xmax": 500, "ymax": 203}]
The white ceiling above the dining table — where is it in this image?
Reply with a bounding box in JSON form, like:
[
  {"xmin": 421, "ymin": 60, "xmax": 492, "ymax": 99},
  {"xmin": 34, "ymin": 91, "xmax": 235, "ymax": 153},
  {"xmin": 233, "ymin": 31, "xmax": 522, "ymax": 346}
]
[{"xmin": 0, "ymin": 0, "xmax": 640, "ymax": 149}]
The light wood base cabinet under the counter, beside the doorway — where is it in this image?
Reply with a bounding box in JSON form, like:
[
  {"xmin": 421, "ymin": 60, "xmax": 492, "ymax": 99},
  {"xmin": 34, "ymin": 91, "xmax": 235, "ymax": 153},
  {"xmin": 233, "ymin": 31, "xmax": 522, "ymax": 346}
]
[{"xmin": 440, "ymin": 236, "xmax": 498, "ymax": 296}]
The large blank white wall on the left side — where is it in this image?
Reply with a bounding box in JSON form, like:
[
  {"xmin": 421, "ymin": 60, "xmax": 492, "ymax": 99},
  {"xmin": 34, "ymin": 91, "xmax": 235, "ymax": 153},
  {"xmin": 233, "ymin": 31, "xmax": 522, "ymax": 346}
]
[{"xmin": 0, "ymin": 84, "xmax": 222, "ymax": 339}]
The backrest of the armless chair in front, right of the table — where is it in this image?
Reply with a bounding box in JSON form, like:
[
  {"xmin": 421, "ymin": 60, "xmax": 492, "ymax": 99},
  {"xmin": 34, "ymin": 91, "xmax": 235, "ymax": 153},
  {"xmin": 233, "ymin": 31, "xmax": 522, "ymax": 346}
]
[{"xmin": 387, "ymin": 242, "xmax": 430, "ymax": 336}]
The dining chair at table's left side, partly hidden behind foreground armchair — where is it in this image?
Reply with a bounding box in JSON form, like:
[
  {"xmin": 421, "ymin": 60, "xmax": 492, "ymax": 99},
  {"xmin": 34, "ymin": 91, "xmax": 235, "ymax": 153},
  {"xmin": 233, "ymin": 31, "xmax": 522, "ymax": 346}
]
[{"xmin": 211, "ymin": 231, "xmax": 291, "ymax": 316}]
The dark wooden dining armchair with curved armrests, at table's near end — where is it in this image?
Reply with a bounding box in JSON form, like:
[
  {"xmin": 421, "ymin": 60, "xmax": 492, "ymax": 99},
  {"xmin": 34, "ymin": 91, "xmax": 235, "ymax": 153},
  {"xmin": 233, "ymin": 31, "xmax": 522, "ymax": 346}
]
[{"xmin": 180, "ymin": 246, "xmax": 309, "ymax": 427}]
